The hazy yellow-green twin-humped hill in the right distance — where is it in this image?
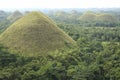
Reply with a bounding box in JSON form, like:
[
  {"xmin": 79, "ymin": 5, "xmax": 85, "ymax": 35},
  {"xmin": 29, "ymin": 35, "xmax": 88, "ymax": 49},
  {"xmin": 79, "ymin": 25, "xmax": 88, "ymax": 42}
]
[{"xmin": 78, "ymin": 11, "xmax": 118, "ymax": 27}]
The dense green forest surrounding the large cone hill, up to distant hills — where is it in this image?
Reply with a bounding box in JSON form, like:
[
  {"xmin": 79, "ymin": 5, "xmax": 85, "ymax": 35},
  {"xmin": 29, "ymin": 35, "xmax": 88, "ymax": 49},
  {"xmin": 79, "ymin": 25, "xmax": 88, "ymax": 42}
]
[{"xmin": 0, "ymin": 8, "xmax": 120, "ymax": 80}]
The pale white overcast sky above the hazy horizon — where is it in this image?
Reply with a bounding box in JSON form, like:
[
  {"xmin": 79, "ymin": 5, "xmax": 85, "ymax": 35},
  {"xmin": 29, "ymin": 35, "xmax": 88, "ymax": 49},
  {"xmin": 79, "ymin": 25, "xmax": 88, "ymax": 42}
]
[{"xmin": 0, "ymin": 0, "xmax": 120, "ymax": 9}]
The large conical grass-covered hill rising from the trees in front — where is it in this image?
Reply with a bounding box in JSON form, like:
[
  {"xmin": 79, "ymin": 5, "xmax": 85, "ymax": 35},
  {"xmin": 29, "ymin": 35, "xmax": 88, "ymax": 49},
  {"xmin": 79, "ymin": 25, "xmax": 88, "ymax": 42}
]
[{"xmin": 0, "ymin": 12, "xmax": 75, "ymax": 55}]
